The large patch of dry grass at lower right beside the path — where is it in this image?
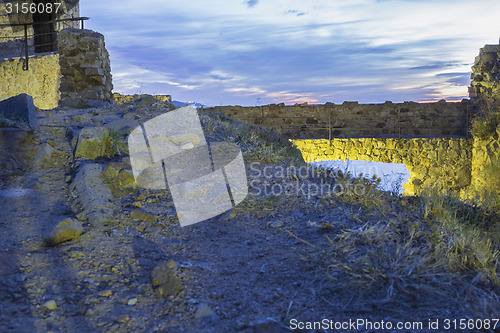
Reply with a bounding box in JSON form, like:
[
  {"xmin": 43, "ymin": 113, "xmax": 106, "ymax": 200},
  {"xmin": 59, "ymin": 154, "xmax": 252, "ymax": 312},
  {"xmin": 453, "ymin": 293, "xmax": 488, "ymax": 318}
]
[{"xmin": 292, "ymin": 184, "xmax": 500, "ymax": 318}]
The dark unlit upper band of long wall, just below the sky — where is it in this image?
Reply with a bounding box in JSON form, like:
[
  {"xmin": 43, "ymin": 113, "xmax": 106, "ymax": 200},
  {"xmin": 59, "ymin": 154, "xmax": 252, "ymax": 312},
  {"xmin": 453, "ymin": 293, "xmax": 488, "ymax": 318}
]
[{"xmin": 207, "ymin": 100, "xmax": 469, "ymax": 139}]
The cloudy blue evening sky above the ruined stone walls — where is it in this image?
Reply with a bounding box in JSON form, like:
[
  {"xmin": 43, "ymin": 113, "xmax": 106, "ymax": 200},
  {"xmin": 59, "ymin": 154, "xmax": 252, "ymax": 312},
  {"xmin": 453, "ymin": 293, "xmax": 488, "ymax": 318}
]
[{"xmin": 80, "ymin": 0, "xmax": 500, "ymax": 106}]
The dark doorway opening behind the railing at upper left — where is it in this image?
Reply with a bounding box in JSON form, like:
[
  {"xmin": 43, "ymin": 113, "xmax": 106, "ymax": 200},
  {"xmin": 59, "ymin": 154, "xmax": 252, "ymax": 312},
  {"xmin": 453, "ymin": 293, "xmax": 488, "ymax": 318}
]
[{"xmin": 33, "ymin": 0, "xmax": 57, "ymax": 53}]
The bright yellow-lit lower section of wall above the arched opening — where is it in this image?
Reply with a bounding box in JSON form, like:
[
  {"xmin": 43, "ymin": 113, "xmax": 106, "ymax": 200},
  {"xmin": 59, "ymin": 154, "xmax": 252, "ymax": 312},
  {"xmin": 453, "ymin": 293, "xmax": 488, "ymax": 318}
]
[{"xmin": 290, "ymin": 138, "xmax": 472, "ymax": 195}]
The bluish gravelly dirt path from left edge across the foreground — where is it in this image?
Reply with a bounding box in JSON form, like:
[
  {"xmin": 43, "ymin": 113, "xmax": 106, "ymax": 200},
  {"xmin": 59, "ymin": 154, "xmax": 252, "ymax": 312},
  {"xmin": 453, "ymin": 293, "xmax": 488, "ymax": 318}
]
[{"xmin": 0, "ymin": 106, "xmax": 328, "ymax": 332}]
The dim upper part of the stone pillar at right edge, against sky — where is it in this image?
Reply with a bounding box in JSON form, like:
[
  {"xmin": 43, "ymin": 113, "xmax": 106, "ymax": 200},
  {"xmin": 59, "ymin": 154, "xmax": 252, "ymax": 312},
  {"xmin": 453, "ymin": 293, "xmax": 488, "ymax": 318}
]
[{"xmin": 469, "ymin": 45, "xmax": 500, "ymax": 112}]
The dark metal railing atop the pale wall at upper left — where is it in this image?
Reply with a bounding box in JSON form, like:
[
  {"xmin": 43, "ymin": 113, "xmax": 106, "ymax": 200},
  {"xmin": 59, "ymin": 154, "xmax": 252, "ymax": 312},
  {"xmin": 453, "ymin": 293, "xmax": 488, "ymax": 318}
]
[{"xmin": 0, "ymin": 17, "xmax": 89, "ymax": 71}]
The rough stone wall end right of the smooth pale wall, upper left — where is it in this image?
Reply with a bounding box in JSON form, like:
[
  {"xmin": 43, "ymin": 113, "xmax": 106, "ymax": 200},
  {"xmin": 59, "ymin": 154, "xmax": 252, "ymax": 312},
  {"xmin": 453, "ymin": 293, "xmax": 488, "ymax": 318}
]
[{"xmin": 58, "ymin": 29, "xmax": 113, "ymax": 107}]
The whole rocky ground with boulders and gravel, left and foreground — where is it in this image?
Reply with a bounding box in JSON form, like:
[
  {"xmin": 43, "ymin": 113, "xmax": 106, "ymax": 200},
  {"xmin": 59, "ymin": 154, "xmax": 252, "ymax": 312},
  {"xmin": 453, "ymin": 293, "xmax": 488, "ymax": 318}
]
[{"xmin": 0, "ymin": 97, "xmax": 500, "ymax": 333}]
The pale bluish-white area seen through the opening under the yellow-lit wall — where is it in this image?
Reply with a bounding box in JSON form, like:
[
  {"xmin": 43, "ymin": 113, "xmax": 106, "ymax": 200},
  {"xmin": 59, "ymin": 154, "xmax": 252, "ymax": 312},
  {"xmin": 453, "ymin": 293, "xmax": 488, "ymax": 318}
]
[{"xmin": 311, "ymin": 160, "xmax": 410, "ymax": 194}]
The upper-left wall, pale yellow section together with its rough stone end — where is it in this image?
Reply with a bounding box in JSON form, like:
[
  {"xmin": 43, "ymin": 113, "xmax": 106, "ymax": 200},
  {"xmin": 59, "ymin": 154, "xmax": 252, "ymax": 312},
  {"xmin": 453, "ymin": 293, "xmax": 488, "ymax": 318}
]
[{"xmin": 0, "ymin": 29, "xmax": 113, "ymax": 109}]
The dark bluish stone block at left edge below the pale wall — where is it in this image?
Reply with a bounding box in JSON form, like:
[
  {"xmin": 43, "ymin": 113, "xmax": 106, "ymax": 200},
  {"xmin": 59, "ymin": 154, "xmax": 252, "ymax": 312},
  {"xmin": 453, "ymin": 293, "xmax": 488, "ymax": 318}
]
[{"xmin": 0, "ymin": 94, "xmax": 37, "ymax": 129}]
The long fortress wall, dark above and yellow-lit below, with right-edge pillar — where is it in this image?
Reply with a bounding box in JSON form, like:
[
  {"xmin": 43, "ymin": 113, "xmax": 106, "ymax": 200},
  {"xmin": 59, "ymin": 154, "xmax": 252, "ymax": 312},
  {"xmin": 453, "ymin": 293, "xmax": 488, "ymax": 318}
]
[{"xmin": 207, "ymin": 45, "xmax": 500, "ymax": 198}]
